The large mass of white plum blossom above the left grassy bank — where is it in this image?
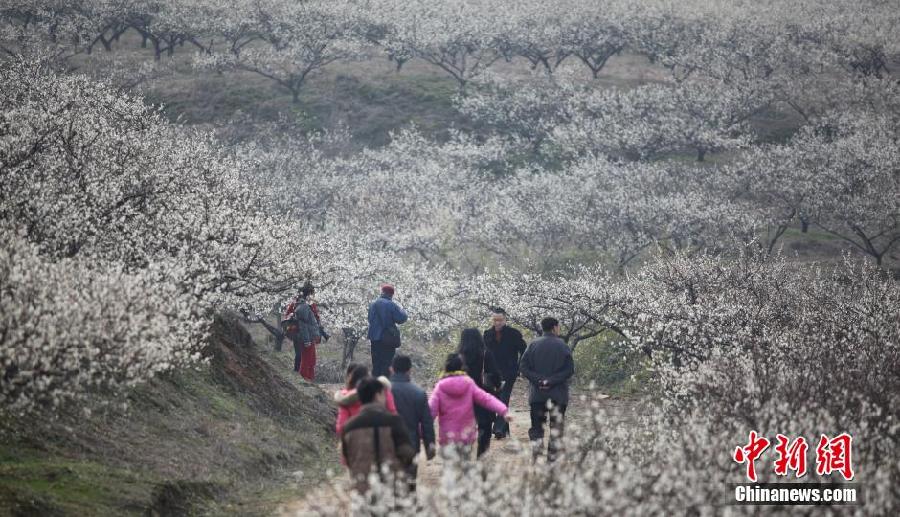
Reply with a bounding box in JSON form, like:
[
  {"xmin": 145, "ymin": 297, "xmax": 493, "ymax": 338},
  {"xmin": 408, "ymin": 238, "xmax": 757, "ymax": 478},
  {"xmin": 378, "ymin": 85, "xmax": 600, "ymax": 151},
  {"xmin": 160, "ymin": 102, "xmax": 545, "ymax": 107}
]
[{"xmin": 0, "ymin": 58, "xmax": 366, "ymax": 411}]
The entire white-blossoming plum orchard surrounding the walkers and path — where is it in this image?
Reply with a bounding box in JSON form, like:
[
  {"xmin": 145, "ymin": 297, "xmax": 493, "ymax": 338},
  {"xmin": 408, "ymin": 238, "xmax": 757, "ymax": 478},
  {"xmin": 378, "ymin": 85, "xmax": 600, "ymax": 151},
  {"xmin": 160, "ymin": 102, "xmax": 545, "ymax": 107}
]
[{"xmin": 0, "ymin": 0, "xmax": 900, "ymax": 515}]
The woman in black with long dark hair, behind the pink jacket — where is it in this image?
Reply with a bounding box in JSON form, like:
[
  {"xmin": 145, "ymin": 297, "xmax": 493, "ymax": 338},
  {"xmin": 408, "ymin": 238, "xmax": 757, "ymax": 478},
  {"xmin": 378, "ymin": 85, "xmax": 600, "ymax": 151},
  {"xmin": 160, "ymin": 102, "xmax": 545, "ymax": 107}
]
[{"xmin": 457, "ymin": 329, "xmax": 506, "ymax": 458}]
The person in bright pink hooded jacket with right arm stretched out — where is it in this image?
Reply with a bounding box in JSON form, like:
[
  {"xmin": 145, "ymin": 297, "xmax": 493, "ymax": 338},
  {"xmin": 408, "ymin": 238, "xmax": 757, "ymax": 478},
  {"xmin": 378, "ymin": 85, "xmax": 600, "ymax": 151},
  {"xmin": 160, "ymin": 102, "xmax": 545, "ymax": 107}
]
[{"xmin": 428, "ymin": 354, "xmax": 512, "ymax": 457}]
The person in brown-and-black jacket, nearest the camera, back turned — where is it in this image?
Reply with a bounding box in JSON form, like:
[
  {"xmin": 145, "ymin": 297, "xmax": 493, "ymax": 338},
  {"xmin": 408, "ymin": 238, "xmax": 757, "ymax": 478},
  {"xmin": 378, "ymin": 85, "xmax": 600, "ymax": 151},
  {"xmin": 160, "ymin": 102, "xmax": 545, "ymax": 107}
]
[{"xmin": 341, "ymin": 377, "xmax": 415, "ymax": 494}]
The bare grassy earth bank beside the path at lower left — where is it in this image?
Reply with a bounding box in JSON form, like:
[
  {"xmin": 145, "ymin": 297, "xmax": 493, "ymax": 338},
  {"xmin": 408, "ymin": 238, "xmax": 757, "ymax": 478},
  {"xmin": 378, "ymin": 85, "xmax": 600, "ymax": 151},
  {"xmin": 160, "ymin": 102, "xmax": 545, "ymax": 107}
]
[{"xmin": 0, "ymin": 317, "xmax": 334, "ymax": 515}]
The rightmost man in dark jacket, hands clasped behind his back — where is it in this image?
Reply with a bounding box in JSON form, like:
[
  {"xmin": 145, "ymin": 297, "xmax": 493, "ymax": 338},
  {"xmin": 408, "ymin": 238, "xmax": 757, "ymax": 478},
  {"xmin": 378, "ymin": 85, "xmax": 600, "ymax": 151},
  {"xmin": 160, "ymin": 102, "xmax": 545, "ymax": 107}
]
[{"xmin": 519, "ymin": 318, "xmax": 575, "ymax": 461}]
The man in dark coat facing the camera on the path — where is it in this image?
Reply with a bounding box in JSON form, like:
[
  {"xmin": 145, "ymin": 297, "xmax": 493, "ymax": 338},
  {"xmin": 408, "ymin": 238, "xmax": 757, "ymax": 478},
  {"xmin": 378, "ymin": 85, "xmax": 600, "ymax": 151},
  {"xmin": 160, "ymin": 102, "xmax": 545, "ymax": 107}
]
[{"xmin": 484, "ymin": 308, "xmax": 526, "ymax": 440}]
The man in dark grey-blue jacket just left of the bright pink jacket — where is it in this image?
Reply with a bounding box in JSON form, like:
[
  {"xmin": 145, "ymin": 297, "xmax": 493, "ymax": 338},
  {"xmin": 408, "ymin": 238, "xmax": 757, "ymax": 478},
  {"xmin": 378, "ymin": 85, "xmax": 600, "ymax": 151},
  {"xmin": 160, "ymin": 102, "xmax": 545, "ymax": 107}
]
[{"xmin": 391, "ymin": 355, "xmax": 435, "ymax": 492}]
